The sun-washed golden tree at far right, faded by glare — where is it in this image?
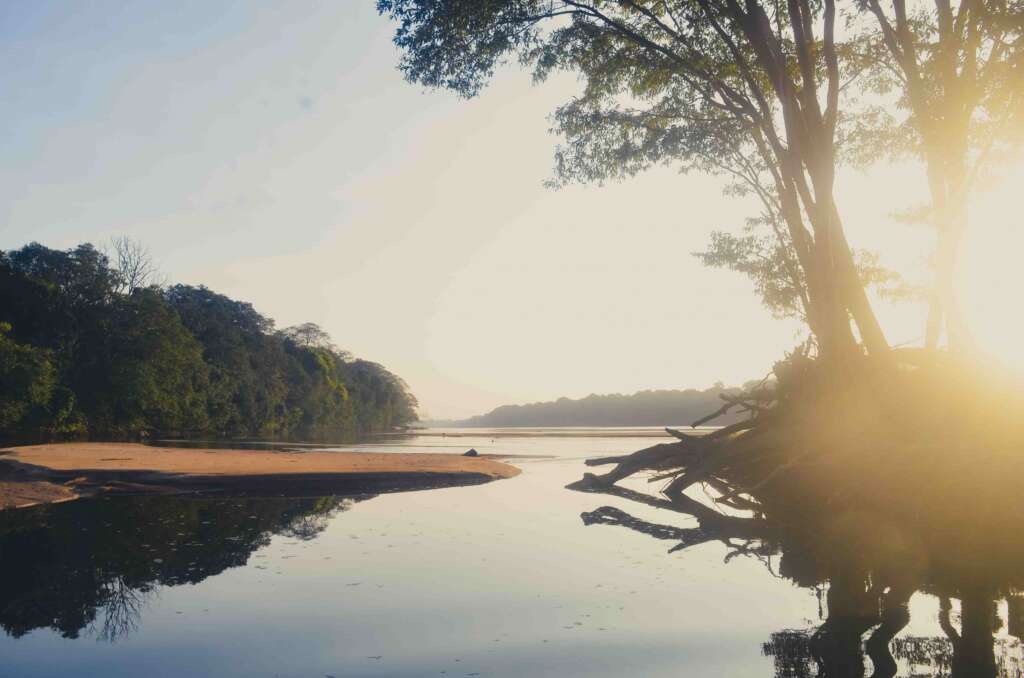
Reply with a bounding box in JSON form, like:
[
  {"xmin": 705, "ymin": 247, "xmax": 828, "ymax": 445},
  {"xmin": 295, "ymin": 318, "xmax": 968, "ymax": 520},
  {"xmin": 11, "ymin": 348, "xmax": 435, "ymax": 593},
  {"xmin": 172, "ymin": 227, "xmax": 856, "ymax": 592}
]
[{"xmin": 859, "ymin": 0, "xmax": 1024, "ymax": 350}]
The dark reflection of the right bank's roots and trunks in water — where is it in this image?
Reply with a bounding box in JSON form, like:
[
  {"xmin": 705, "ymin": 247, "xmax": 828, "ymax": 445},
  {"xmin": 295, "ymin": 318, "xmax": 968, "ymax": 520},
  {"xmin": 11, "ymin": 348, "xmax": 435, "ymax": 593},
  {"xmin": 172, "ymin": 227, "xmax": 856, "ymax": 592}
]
[{"xmin": 578, "ymin": 485, "xmax": 1024, "ymax": 678}]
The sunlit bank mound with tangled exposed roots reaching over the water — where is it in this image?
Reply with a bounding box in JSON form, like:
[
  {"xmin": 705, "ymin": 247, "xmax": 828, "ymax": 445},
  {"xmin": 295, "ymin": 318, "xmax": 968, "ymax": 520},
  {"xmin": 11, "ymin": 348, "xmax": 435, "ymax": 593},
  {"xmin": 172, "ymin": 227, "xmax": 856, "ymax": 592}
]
[{"xmin": 569, "ymin": 349, "xmax": 1024, "ymax": 561}]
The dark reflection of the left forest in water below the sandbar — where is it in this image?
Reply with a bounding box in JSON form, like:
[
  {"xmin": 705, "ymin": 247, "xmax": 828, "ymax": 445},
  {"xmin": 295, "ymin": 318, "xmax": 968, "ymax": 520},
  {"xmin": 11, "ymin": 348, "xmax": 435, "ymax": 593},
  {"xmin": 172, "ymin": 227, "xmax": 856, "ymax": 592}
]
[{"xmin": 0, "ymin": 496, "xmax": 370, "ymax": 641}]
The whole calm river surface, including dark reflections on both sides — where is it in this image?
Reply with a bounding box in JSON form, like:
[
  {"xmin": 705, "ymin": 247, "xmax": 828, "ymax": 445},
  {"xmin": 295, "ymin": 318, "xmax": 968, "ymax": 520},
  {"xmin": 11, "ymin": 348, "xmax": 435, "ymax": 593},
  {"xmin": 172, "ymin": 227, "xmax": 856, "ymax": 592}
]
[{"xmin": 8, "ymin": 434, "xmax": 1024, "ymax": 678}]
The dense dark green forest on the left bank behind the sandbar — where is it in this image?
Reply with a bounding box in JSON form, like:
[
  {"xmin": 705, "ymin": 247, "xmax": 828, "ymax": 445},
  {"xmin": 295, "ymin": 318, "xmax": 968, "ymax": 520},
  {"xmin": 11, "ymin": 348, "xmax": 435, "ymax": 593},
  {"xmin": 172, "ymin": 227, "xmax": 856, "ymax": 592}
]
[{"xmin": 0, "ymin": 240, "xmax": 417, "ymax": 437}]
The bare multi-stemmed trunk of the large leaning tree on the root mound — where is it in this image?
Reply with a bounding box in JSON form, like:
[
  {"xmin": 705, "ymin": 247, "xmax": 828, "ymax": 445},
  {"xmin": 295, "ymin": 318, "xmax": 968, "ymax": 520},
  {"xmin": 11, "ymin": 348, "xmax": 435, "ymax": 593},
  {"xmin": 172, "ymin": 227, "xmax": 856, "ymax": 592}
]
[{"xmin": 729, "ymin": 0, "xmax": 889, "ymax": 357}]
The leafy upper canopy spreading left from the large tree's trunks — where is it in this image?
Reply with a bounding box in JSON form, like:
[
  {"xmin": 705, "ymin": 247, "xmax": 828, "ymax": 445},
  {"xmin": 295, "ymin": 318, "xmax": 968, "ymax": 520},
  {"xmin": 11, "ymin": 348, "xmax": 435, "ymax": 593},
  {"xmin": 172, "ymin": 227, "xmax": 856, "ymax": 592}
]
[{"xmin": 378, "ymin": 0, "xmax": 767, "ymax": 191}]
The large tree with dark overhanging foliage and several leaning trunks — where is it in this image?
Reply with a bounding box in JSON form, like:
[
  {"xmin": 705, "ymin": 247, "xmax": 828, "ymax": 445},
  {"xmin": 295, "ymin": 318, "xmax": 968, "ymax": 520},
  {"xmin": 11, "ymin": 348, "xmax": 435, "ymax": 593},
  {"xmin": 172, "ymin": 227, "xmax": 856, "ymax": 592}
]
[{"xmin": 378, "ymin": 0, "xmax": 888, "ymax": 355}]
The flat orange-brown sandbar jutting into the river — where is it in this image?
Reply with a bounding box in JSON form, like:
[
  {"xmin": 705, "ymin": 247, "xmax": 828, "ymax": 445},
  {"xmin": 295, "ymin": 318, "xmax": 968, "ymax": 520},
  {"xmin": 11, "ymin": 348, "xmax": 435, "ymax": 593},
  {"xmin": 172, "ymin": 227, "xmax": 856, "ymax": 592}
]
[{"xmin": 0, "ymin": 442, "xmax": 519, "ymax": 508}]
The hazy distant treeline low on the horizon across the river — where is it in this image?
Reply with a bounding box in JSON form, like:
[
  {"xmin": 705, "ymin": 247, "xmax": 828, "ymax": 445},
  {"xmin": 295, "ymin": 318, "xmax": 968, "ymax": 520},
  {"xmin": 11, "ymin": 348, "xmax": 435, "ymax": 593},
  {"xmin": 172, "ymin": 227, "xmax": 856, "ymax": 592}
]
[{"xmin": 461, "ymin": 385, "xmax": 739, "ymax": 427}]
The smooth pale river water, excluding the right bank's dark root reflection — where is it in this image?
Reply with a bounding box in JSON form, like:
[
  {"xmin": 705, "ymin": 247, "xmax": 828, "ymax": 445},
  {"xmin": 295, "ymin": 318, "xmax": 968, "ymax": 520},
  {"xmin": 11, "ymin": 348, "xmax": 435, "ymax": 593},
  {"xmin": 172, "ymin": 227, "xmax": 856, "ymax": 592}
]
[{"xmin": 0, "ymin": 429, "xmax": 1020, "ymax": 678}]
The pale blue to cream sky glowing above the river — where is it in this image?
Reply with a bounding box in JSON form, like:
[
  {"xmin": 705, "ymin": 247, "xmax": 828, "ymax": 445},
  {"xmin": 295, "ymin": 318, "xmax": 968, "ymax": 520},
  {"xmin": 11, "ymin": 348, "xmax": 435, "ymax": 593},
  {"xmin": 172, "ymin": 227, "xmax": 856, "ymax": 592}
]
[{"xmin": 0, "ymin": 0, "xmax": 1024, "ymax": 418}]
